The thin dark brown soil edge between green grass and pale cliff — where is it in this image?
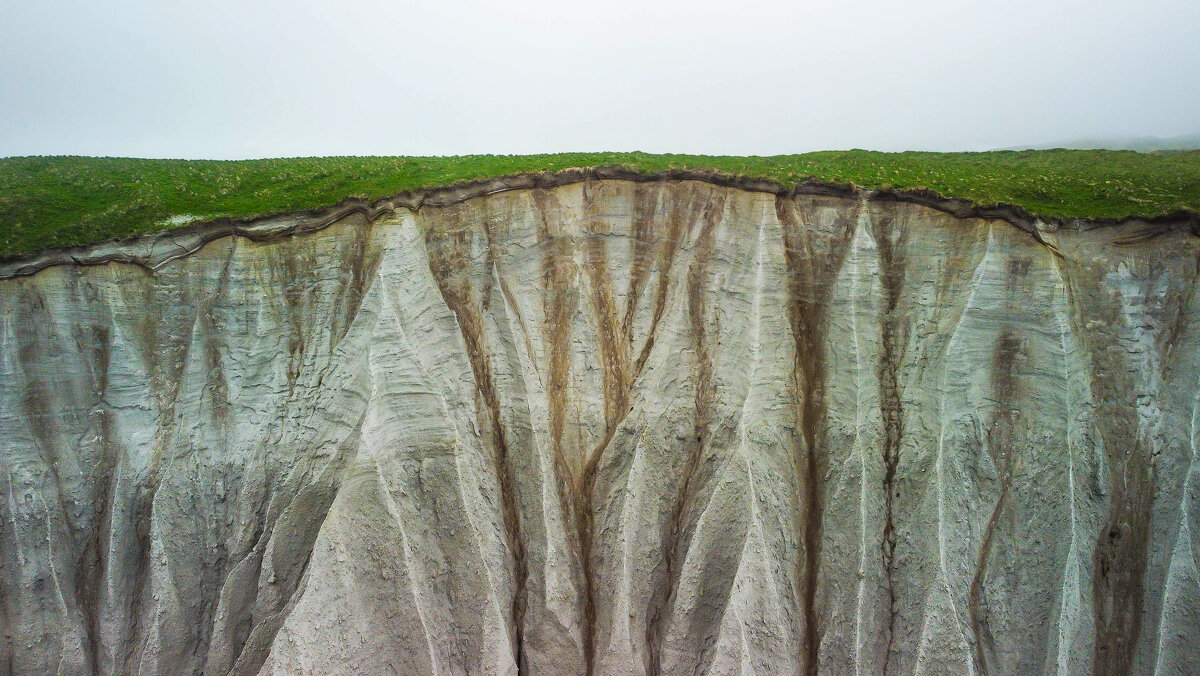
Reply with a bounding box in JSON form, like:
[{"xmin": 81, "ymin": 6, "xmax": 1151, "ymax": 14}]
[{"xmin": 0, "ymin": 166, "xmax": 1200, "ymax": 280}]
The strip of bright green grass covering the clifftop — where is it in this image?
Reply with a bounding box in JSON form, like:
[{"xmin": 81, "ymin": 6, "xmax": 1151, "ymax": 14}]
[{"xmin": 0, "ymin": 150, "xmax": 1200, "ymax": 256}]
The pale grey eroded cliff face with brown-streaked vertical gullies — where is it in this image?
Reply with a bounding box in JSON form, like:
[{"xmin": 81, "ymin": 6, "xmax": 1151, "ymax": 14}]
[{"xmin": 0, "ymin": 180, "xmax": 1200, "ymax": 675}]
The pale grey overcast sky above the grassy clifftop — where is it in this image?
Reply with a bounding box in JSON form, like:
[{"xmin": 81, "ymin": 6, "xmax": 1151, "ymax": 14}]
[{"xmin": 0, "ymin": 0, "xmax": 1200, "ymax": 158}]
